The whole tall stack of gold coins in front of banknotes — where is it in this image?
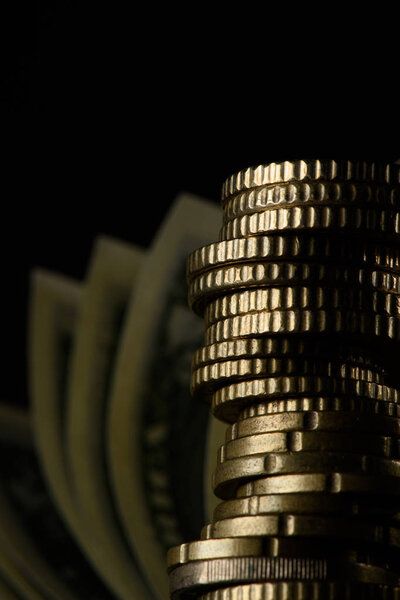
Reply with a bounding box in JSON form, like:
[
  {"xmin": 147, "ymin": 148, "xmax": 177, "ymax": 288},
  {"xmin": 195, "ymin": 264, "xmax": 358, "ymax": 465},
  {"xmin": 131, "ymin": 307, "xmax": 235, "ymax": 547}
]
[{"xmin": 168, "ymin": 160, "xmax": 400, "ymax": 600}]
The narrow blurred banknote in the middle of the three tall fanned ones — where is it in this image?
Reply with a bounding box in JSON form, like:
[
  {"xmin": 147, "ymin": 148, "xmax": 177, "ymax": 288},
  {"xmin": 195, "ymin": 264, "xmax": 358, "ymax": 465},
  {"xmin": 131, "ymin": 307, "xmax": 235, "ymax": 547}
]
[{"xmin": 65, "ymin": 236, "xmax": 154, "ymax": 600}]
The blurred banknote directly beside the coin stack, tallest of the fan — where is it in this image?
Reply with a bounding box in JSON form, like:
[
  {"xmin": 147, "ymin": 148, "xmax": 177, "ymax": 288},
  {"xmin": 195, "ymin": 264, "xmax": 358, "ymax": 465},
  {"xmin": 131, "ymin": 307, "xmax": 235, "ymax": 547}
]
[{"xmin": 107, "ymin": 194, "xmax": 220, "ymax": 600}]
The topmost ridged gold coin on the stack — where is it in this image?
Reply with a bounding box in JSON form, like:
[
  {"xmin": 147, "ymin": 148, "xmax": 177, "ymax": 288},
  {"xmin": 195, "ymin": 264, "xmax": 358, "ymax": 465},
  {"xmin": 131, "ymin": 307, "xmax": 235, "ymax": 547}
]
[{"xmin": 222, "ymin": 159, "xmax": 400, "ymax": 203}]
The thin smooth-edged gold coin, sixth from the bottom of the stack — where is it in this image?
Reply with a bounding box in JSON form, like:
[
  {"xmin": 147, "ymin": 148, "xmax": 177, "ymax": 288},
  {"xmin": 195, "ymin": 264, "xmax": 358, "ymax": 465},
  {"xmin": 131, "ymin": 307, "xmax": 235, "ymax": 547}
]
[{"xmin": 237, "ymin": 472, "xmax": 400, "ymax": 498}]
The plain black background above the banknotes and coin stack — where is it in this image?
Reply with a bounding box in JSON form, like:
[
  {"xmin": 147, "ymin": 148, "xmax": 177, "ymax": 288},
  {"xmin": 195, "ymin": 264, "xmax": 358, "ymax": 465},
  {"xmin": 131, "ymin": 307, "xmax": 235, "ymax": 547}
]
[{"xmin": 0, "ymin": 0, "xmax": 400, "ymax": 403}]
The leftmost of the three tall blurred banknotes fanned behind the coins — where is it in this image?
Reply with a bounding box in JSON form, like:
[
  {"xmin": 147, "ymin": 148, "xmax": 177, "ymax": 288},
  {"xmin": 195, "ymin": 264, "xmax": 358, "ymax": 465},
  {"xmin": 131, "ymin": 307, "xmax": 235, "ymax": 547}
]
[{"xmin": 27, "ymin": 269, "xmax": 112, "ymax": 600}]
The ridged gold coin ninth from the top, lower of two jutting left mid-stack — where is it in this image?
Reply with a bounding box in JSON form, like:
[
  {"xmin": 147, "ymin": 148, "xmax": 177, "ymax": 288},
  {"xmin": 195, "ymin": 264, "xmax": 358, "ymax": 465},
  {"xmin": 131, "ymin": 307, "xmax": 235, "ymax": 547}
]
[{"xmin": 190, "ymin": 357, "xmax": 385, "ymax": 398}]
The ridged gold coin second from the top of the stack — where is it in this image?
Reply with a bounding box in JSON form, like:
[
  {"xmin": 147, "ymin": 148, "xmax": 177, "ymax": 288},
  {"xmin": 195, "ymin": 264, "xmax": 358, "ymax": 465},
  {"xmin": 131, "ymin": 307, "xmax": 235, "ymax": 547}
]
[{"xmin": 223, "ymin": 181, "xmax": 400, "ymax": 223}]
